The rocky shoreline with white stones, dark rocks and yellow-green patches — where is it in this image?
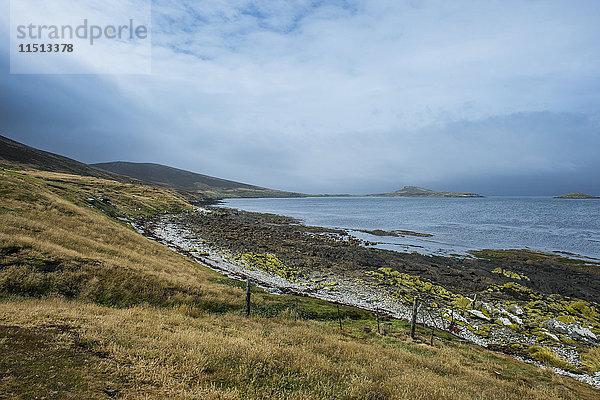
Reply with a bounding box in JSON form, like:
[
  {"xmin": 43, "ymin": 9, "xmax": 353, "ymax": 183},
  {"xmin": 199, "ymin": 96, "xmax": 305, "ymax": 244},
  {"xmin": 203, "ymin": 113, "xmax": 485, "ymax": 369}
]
[{"xmin": 135, "ymin": 207, "xmax": 600, "ymax": 388}]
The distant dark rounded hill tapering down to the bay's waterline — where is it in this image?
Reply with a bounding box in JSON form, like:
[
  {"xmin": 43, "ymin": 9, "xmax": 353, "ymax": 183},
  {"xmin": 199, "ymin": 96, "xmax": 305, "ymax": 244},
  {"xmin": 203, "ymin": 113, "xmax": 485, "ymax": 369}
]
[{"xmin": 93, "ymin": 161, "xmax": 302, "ymax": 197}]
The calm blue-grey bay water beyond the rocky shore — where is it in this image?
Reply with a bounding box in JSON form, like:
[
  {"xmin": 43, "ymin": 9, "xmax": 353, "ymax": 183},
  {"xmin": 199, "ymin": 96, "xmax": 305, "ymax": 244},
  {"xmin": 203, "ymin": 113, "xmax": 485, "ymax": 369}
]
[{"xmin": 225, "ymin": 197, "xmax": 600, "ymax": 258}]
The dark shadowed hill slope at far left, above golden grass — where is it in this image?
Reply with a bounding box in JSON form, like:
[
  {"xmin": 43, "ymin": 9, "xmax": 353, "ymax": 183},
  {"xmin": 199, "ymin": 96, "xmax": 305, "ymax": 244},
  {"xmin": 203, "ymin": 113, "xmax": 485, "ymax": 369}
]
[{"xmin": 0, "ymin": 136, "xmax": 124, "ymax": 181}]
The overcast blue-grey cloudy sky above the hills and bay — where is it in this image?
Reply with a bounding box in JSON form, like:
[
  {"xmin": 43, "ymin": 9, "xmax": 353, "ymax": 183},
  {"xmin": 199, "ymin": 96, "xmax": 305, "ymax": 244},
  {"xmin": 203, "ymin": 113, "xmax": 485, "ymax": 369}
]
[{"xmin": 0, "ymin": 0, "xmax": 600, "ymax": 195}]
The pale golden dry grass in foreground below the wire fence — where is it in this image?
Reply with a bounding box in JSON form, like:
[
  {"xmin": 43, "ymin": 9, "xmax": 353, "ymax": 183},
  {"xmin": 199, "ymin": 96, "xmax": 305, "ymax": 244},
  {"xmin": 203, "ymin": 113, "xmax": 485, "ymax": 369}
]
[{"xmin": 0, "ymin": 299, "xmax": 597, "ymax": 399}]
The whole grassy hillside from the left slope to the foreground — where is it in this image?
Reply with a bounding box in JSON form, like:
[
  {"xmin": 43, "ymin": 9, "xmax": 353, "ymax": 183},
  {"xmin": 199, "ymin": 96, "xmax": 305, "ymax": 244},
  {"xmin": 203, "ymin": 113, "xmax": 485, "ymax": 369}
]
[{"xmin": 0, "ymin": 166, "xmax": 598, "ymax": 399}]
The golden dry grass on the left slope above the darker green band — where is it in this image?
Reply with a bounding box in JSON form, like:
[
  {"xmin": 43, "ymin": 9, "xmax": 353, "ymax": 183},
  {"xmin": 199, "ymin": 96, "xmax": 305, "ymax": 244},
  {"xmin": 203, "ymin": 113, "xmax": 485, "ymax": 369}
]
[{"xmin": 0, "ymin": 171, "xmax": 212, "ymax": 300}]
